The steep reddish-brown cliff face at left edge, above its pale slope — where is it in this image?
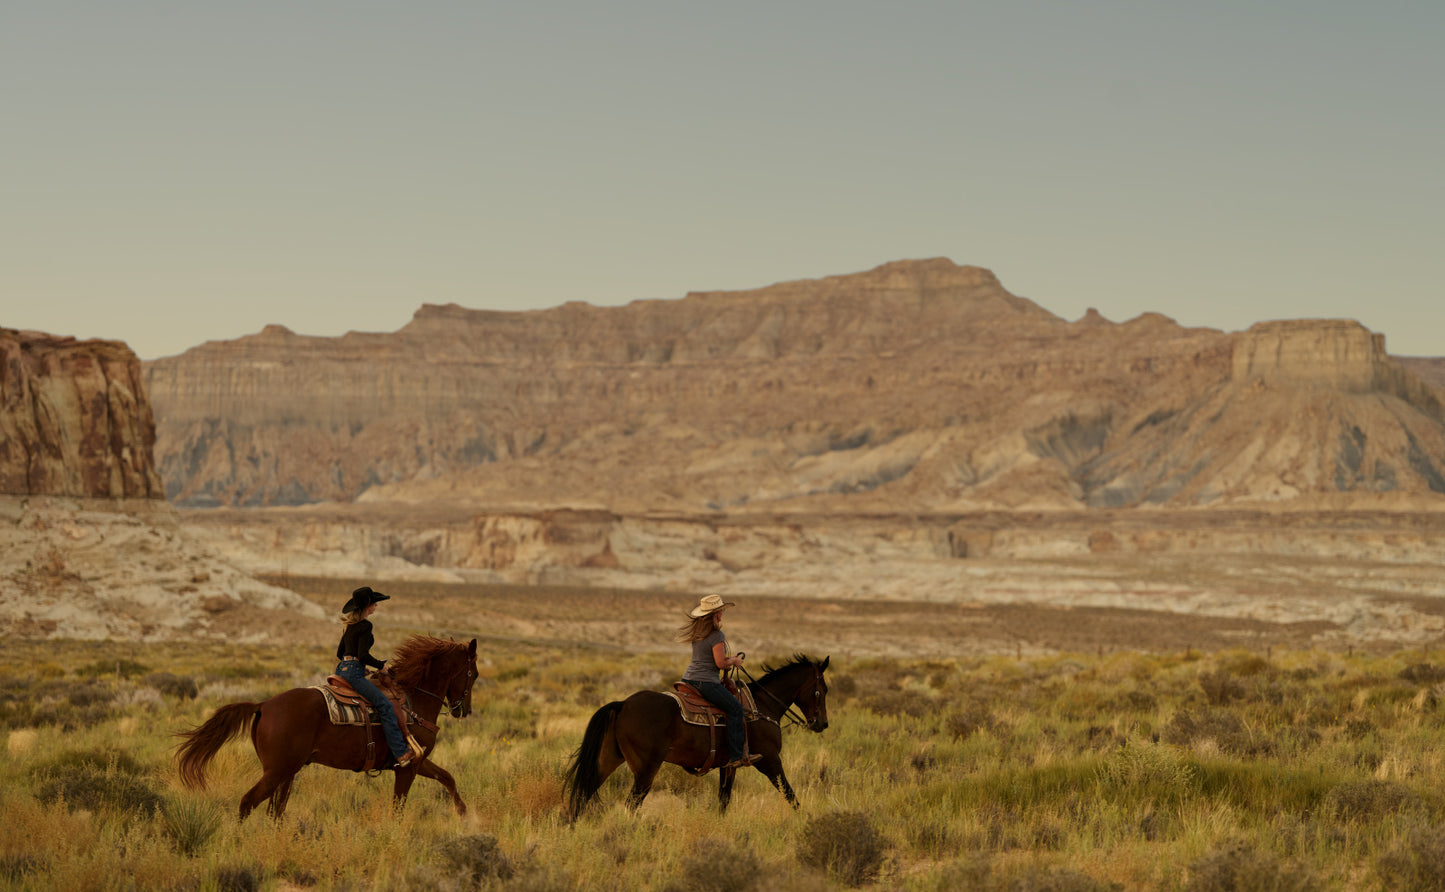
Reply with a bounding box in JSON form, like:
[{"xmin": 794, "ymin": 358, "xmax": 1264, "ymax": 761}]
[{"xmin": 0, "ymin": 328, "xmax": 165, "ymax": 499}]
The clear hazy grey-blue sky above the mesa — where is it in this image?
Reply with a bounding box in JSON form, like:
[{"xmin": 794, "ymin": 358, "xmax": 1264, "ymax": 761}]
[{"xmin": 0, "ymin": 0, "xmax": 1445, "ymax": 359}]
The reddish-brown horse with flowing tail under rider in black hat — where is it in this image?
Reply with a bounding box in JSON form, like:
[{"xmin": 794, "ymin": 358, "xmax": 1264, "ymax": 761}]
[{"xmin": 176, "ymin": 635, "xmax": 477, "ymax": 820}]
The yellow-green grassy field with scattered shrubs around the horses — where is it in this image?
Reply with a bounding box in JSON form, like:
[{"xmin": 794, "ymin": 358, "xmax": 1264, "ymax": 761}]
[{"xmin": 0, "ymin": 584, "xmax": 1445, "ymax": 892}]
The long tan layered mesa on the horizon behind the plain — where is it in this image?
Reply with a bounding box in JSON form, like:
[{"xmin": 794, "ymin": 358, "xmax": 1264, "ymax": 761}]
[{"xmin": 146, "ymin": 259, "xmax": 1445, "ymax": 515}]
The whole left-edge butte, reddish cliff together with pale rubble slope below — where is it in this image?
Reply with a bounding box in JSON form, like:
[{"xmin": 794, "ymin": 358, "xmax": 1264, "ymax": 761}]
[{"xmin": 0, "ymin": 328, "xmax": 321, "ymax": 640}]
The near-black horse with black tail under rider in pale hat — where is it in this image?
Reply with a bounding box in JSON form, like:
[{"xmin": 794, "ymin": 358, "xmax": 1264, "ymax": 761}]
[{"xmin": 565, "ymin": 653, "xmax": 828, "ymax": 818}]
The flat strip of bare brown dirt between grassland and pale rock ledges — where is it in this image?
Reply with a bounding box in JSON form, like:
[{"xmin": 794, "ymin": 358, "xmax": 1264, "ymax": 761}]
[{"xmin": 267, "ymin": 577, "xmax": 1392, "ymax": 659}]
